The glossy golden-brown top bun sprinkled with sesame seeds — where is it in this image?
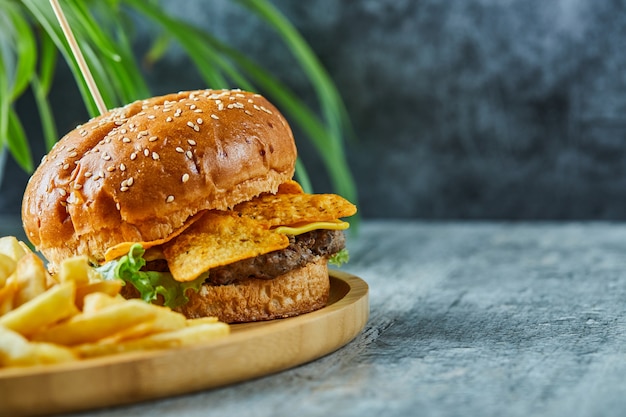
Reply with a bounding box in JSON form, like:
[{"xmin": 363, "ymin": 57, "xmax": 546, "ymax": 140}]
[{"xmin": 22, "ymin": 90, "xmax": 296, "ymax": 269}]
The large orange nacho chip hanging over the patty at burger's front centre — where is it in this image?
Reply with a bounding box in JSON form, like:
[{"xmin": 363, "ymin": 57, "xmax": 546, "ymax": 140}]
[{"xmin": 163, "ymin": 211, "xmax": 289, "ymax": 282}]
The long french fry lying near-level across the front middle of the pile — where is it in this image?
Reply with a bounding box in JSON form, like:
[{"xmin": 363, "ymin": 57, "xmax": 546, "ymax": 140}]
[{"xmin": 32, "ymin": 300, "xmax": 156, "ymax": 346}]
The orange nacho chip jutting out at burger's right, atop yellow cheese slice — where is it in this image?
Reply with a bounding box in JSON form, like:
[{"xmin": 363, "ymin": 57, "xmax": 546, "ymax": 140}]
[{"xmin": 234, "ymin": 194, "xmax": 356, "ymax": 226}]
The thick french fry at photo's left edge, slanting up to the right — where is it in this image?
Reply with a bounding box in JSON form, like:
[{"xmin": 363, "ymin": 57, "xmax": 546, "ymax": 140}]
[{"xmin": 0, "ymin": 282, "xmax": 78, "ymax": 337}]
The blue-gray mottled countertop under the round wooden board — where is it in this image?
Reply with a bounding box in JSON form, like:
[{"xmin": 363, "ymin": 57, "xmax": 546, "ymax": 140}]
[{"xmin": 0, "ymin": 219, "xmax": 626, "ymax": 417}]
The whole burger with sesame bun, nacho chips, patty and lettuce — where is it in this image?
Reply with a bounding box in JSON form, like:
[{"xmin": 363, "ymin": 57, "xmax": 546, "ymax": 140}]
[{"xmin": 22, "ymin": 90, "xmax": 356, "ymax": 323}]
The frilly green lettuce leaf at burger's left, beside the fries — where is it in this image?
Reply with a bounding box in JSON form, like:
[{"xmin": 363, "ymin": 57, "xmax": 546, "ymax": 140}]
[{"xmin": 96, "ymin": 244, "xmax": 205, "ymax": 308}]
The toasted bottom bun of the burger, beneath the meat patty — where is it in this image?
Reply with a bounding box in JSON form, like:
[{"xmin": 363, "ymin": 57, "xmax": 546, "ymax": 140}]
[{"xmin": 176, "ymin": 258, "xmax": 330, "ymax": 323}]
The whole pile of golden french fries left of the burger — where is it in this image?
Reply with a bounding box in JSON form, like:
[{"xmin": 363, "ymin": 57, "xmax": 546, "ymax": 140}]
[{"xmin": 0, "ymin": 236, "xmax": 230, "ymax": 368}]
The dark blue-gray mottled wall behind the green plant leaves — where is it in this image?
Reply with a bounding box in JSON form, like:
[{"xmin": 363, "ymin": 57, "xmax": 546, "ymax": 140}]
[{"xmin": 0, "ymin": 0, "xmax": 626, "ymax": 219}]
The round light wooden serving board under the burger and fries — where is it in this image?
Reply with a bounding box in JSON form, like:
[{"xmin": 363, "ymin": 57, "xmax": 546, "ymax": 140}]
[{"xmin": 0, "ymin": 271, "xmax": 369, "ymax": 416}]
